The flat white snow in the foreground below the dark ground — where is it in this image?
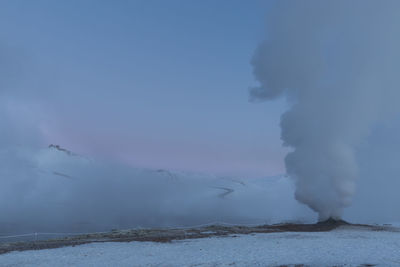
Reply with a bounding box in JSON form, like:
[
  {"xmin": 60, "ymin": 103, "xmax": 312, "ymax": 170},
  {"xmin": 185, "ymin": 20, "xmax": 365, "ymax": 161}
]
[{"xmin": 0, "ymin": 228, "xmax": 400, "ymax": 266}]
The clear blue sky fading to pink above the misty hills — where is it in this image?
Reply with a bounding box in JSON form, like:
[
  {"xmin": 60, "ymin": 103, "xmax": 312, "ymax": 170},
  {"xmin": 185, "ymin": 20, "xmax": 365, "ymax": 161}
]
[{"xmin": 0, "ymin": 0, "xmax": 285, "ymax": 176}]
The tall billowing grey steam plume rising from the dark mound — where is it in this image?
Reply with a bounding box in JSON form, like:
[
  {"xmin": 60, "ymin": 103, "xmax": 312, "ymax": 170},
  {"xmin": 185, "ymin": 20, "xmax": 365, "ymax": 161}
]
[{"xmin": 250, "ymin": 0, "xmax": 400, "ymax": 220}]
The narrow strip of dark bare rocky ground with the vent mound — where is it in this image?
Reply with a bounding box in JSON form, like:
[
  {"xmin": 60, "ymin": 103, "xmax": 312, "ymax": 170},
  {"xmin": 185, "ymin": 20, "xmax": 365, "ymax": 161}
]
[{"xmin": 0, "ymin": 219, "xmax": 391, "ymax": 254}]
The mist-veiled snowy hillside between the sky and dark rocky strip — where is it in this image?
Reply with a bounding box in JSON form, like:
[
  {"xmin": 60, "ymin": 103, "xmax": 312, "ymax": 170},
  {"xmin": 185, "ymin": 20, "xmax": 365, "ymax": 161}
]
[{"xmin": 0, "ymin": 146, "xmax": 315, "ymax": 236}]
